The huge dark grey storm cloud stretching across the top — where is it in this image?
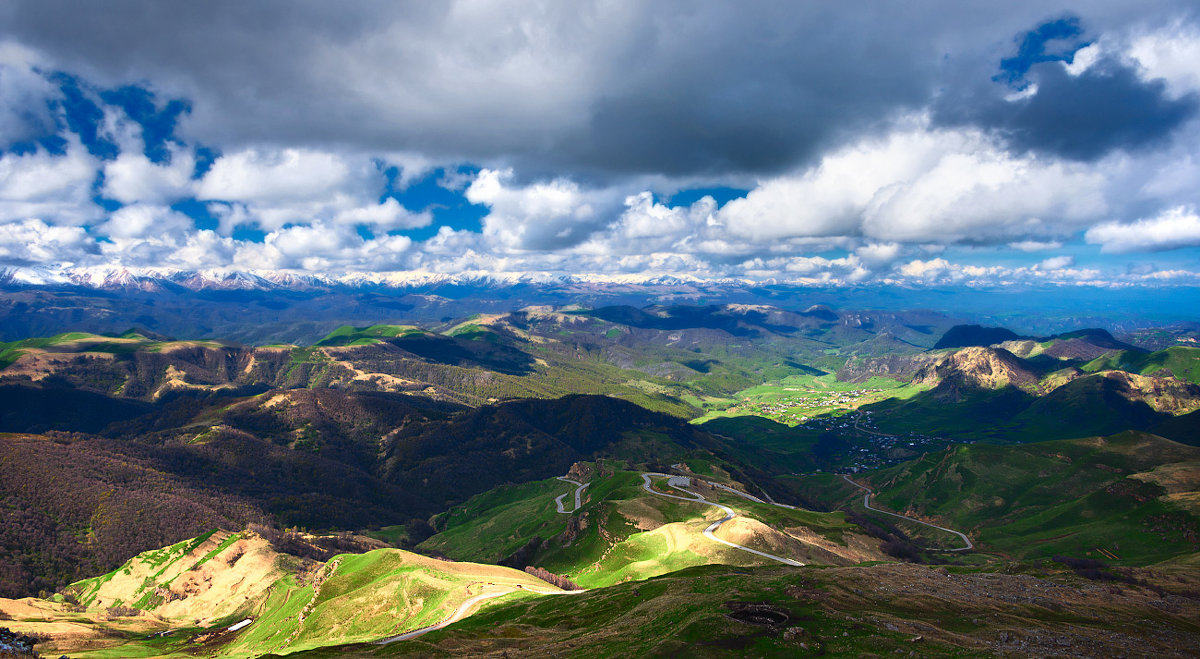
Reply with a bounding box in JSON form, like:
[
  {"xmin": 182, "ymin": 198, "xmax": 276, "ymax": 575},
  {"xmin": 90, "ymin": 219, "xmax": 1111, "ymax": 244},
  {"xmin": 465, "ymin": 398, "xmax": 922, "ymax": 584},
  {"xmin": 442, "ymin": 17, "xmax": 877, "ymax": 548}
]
[{"xmin": 7, "ymin": 0, "xmax": 1161, "ymax": 180}]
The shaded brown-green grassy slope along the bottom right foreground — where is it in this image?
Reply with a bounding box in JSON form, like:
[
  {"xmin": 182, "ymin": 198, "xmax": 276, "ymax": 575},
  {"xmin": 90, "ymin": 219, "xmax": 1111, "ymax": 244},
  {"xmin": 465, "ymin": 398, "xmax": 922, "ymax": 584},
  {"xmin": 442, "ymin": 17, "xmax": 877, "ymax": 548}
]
[{"xmin": 276, "ymin": 565, "xmax": 1200, "ymax": 659}]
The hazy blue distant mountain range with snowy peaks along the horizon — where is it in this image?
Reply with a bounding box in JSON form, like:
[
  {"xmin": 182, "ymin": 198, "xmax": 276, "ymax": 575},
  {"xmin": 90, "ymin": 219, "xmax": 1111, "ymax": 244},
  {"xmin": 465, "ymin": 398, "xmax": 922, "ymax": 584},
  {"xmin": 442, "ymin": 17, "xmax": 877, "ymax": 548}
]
[{"xmin": 7, "ymin": 266, "xmax": 1200, "ymax": 347}]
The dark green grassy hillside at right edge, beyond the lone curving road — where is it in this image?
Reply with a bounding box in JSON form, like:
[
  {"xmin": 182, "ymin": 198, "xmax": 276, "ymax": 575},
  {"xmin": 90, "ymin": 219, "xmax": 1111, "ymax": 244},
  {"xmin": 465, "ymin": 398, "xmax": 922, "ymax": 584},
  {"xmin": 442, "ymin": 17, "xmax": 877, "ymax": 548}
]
[{"xmin": 868, "ymin": 432, "xmax": 1200, "ymax": 564}]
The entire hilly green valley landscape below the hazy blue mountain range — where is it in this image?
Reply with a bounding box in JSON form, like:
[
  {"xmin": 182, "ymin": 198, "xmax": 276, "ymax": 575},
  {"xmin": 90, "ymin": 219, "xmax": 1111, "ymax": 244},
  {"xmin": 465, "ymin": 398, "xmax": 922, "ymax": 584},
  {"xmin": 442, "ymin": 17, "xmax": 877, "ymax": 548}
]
[{"xmin": 0, "ymin": 305, "xmax": 1200, "ymax": 658}]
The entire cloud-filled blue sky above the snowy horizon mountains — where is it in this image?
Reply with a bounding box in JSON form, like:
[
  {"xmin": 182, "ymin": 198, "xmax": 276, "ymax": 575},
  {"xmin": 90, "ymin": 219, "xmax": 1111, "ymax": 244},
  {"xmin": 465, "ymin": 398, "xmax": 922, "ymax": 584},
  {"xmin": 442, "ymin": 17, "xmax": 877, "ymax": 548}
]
[{"xmin": 0, "ymin": 0, "xmax": 1200, "ymax": 287}]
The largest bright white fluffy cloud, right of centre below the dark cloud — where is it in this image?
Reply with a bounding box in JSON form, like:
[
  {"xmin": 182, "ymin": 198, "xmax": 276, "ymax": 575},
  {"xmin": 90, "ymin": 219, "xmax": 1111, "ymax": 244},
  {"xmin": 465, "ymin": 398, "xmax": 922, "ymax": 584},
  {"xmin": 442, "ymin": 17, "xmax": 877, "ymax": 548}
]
[{"xmin": 720, "ymin": 125, "xmax": 1106, "ymax": 242}]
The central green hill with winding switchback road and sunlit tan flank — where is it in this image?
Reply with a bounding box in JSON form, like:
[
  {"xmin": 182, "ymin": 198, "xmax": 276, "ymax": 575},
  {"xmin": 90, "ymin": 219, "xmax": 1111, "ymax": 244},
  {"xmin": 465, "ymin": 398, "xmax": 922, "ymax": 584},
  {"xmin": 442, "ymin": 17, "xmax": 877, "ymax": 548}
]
[{"xmin": 420, "ymin": 465, "xmax": 883, "ymax": 587}]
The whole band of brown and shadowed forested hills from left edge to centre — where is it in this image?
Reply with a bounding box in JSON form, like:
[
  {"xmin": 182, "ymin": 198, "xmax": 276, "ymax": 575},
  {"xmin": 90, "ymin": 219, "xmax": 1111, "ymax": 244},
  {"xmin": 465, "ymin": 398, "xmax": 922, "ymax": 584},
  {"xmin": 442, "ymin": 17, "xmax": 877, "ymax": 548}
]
[{"xmin": 0, "ymin": 389, "xmax": 740, "ymax": 595}]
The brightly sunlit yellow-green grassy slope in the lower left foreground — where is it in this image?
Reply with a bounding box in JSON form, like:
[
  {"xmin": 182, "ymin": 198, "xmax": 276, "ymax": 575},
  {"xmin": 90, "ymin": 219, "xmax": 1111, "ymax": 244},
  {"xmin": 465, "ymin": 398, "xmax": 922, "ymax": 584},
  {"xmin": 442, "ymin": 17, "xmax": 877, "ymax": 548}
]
[{"xmin": 15, "ymin": 532, "xmax": 556, "ymax": 658}]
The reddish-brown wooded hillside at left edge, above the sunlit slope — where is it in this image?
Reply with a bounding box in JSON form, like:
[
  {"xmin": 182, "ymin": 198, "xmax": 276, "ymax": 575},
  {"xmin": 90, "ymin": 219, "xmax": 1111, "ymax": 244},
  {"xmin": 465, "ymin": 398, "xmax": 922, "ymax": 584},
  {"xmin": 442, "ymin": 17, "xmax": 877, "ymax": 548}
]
[{"xmin": 0, "ymin": 433, "xmax": 265, "ymax": 597}]
